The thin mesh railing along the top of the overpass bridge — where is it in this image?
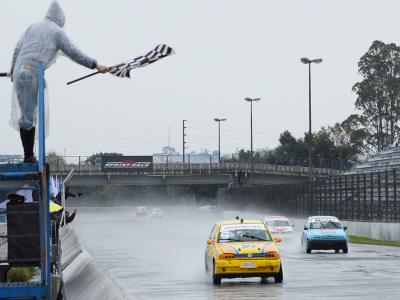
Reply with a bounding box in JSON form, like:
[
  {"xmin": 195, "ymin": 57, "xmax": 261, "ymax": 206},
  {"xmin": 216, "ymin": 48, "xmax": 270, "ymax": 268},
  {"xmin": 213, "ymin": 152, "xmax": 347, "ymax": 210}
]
[{"xmin": 47, "ymin": 156, "xmax": 341, "ymax": 177}]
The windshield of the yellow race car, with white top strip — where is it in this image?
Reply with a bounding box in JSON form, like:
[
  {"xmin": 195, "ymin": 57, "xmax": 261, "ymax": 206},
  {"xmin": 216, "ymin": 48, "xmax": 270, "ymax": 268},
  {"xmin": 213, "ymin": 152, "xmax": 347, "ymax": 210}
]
[{"xmin": 218, "ymin": 224, "xmax": 272, "ymax": 243}]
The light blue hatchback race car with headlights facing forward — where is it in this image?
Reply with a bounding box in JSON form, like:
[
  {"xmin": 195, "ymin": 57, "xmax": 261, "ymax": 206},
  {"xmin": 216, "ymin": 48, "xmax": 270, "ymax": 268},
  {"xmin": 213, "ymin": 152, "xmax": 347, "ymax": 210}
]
[{"xmin": 301, "ymin": 216, "xmax": 349, "ymax": 253}]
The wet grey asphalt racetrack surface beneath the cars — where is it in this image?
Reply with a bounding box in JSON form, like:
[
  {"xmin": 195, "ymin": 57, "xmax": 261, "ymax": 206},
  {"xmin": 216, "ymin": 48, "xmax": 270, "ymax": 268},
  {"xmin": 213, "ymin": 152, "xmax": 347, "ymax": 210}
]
[{"xmin": 73, "ymin": 207, "xmax": 400, "ymax": 300}]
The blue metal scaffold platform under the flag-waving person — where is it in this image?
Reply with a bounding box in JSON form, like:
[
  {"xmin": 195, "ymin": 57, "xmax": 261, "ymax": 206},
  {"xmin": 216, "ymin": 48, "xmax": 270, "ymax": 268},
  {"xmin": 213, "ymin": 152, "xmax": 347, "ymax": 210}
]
[{"xmin": 0, "ymin": 65, "xmax": 57, "ymax": 299}]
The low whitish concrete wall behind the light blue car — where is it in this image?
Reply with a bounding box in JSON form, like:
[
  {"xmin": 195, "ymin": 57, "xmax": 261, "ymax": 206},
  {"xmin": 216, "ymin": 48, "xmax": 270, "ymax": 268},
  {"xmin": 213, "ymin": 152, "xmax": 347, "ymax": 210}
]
[{"xmin": 291, "ymin": 219, "xmax": 400, "ymax": 241}]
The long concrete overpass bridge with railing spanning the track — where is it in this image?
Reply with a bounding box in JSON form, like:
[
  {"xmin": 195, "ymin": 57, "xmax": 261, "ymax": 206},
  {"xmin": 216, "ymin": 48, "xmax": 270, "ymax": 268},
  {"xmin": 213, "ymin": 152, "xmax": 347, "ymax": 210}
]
[{"xmin": 50, "ymin": 162, "xmax": 341, "ymax": 186}]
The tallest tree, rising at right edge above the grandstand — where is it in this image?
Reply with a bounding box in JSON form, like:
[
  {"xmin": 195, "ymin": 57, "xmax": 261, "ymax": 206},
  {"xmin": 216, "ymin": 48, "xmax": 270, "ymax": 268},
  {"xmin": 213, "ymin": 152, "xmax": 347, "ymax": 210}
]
[{"xmin": 353, "ymin": 41, "xmax": 400, "ymax": 151}]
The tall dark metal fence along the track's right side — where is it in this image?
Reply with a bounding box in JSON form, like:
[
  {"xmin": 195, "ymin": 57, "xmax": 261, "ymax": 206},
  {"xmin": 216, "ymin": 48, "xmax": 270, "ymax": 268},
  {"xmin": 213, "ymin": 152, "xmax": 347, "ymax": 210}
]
[{"xmin": 228, "ymin": 169, "xmax": 400, "ymax": 222}]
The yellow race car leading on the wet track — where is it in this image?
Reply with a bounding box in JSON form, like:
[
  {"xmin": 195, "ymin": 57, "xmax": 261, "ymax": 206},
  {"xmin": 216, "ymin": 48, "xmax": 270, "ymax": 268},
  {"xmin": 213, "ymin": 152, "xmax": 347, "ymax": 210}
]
[{"xmin": 205, "ymin": 219, "xmax": 283, "ymax": 285}]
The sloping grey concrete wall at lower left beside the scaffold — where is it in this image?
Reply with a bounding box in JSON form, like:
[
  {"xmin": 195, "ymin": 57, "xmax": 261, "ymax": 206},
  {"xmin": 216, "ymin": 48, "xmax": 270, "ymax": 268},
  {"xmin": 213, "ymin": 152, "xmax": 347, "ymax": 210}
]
[{"xmin": 60, "ymin": 226, "xmax": 126, "ymax": 300}]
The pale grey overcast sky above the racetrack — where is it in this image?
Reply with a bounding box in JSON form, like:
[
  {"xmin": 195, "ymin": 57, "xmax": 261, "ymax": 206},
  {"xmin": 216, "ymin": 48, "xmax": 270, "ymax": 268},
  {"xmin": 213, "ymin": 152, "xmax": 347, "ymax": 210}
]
[{"xmin": 0, "ymin": 0, "xmax": 400, "ymax": 155}]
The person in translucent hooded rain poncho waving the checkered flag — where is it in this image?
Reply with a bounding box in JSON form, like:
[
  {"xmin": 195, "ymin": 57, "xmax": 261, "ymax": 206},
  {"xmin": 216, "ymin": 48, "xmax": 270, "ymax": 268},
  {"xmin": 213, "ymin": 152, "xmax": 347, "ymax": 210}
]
[{"xmin": 9, "ymin": 1, "xmax": 108, "ymax": 163}]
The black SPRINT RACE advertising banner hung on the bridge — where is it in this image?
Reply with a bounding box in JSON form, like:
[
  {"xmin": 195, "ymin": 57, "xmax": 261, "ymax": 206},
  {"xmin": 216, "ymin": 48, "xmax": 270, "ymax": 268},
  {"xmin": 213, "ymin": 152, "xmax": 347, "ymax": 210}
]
[{"xmin": 101, "ymin": 156, "xmax": 153, "ymax": 172}]
